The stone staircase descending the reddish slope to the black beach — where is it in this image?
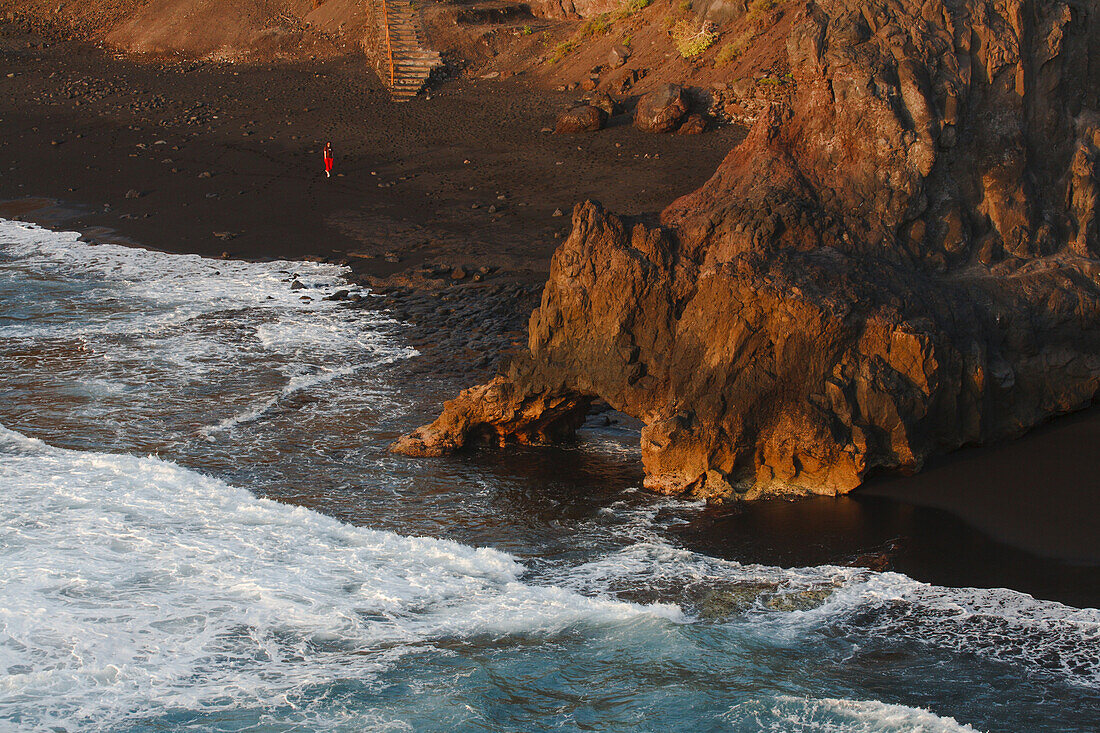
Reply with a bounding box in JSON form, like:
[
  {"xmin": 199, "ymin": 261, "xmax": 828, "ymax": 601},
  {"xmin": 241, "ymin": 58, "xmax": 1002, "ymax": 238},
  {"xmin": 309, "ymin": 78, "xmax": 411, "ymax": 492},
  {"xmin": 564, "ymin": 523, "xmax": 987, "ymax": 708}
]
[{"xmin": 374, "ymin": 0, "xmax": 442, "ymax": 101}]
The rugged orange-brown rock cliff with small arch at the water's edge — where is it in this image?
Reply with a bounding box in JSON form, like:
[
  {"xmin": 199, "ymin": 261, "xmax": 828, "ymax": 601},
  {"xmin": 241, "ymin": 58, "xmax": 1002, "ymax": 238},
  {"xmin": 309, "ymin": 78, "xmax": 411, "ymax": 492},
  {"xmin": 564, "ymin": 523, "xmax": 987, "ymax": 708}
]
[{"xmin": 394, "ymin": 0, "xmax": 1100, "ymax": 499}]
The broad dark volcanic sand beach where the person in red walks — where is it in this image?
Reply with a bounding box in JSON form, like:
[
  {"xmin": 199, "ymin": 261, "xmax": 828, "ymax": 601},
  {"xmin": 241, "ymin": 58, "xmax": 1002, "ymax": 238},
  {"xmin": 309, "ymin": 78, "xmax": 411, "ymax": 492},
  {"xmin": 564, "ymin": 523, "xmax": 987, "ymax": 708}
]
[{"xmin": 0, "ymin": 26, "xmax": 741, "ymax": 281}]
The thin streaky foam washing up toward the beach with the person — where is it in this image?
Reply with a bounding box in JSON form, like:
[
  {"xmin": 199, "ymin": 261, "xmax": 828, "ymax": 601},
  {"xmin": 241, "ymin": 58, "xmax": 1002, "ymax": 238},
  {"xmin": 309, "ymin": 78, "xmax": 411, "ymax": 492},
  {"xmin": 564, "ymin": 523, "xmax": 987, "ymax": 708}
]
[{"xmin": 0, "ymin": 215, "xmax": 416, "ymax": 451}]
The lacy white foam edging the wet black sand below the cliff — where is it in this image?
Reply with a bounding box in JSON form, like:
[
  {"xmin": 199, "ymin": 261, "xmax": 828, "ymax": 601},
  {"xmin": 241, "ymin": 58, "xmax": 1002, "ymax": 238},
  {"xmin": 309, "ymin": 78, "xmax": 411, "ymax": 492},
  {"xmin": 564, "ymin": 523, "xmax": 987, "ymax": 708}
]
[{"xmin": 552, "ymin": 538, "xmax": 1100, "ymax": 690}]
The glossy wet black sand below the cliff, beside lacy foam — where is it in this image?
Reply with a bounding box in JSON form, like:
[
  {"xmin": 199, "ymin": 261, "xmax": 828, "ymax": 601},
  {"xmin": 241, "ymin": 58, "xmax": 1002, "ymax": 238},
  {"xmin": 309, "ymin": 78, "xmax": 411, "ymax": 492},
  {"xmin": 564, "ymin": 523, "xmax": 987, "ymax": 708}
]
[{"xmin": 680, "ymin": 484, "xmax": 1100, "ymax": 608}]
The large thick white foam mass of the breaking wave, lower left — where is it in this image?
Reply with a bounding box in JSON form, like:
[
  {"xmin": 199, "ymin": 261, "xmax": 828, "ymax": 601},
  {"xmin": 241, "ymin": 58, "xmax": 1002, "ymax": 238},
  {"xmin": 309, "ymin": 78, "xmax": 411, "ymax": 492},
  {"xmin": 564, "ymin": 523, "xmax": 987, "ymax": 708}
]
[{"xmin": 0, "ymin": 428, "xmax": 681, "ymax": 730}]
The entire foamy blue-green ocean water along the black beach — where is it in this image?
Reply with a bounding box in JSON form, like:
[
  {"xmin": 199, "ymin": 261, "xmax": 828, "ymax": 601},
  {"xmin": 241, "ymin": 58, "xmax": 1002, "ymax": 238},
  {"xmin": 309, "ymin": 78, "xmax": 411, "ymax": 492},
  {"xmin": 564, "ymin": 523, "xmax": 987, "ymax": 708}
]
[{"xmin": 0, "ymin": 221, "xmax": 1100, "ymax": 732}]
